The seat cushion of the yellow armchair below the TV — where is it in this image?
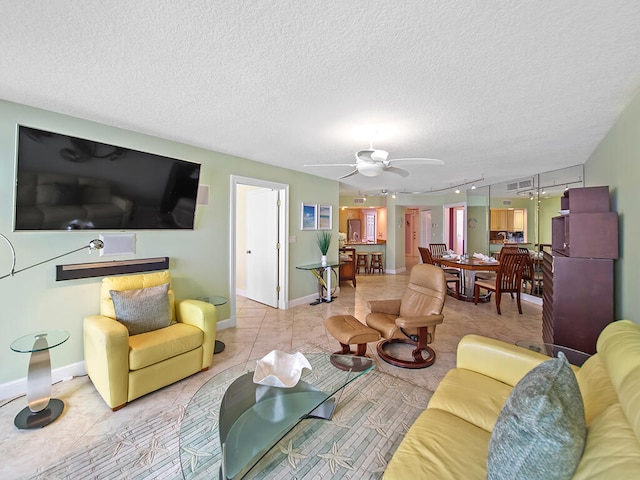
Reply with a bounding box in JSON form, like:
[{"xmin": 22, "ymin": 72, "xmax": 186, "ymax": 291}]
[{"xmin": 129, "ymin": 323, "xmax": 204, "ymax": 370}]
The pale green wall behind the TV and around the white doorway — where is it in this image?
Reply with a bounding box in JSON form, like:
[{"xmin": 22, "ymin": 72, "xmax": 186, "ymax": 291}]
[{"xmin": 0, "ymin": 100, "xmax": 338, "ymax": 384}]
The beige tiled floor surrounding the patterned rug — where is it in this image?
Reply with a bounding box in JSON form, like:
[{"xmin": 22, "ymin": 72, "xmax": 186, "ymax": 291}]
[{"xmin": 0, "ymin": 260, "xmax": 542, "ymax": 478}]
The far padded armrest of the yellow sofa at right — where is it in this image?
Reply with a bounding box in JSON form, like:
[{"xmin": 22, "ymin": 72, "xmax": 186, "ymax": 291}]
[{"xmin": 457, "ymin": 335, "xmax": 549, "ymax": 386}]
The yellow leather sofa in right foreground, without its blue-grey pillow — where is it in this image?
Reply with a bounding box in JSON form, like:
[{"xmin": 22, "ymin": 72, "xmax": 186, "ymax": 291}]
[{"xmin": 383, "ymin": 320, "xmax": 640, "ymax": 480}]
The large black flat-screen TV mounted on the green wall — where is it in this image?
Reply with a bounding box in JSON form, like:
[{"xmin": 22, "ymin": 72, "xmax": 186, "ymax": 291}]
[{"xmin": 15, "ymin": 126, "xmax": 200, "ymax": 231}]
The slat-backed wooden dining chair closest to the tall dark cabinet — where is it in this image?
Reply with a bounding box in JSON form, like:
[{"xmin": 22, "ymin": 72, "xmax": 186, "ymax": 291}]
[{"xmin": 473, "ymin": 249, "xmax": 530, "ymax": 315}]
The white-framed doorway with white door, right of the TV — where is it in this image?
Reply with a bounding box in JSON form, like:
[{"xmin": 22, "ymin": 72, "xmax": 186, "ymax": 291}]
[{"xmin": 229, "ymin": 175, "xmax": 289, "ymax": 325}]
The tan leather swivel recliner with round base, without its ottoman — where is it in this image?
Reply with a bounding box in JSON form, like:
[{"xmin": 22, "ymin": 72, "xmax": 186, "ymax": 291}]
[{"xmin": 366, "ymin": 264, "xmax": 447, "ymax": 368}]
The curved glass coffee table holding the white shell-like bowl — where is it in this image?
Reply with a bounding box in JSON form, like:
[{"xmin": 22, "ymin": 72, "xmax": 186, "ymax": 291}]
[{"xmin": 180, "ymin": 353, "xmax": 374, "ymax": 480}]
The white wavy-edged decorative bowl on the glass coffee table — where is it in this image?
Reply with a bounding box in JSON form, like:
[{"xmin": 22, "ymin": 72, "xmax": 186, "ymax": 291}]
[{"xmin": 253, "ymin": 350, "xmax": 312, "ymax": 388}]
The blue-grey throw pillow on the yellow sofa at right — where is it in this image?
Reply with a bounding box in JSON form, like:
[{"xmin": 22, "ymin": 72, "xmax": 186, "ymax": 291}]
[{"xmin": 487, "ymin": 353, "xmax": 586, "ymax": 480}]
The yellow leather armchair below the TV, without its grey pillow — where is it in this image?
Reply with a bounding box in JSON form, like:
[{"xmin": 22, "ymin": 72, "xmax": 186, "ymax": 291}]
[{"xmin": 84, "ymin": 271, "xmax": 217, "ymax": 411}]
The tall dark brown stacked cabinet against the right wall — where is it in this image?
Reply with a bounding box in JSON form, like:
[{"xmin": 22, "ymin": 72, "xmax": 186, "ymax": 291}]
[{"xmin": 542, "ymin": 187, "xmax": 618, "ymax": 354}]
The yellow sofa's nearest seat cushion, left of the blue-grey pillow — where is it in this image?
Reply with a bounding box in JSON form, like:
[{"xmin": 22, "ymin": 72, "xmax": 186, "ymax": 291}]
[{"xmin": 383, "ymin": 408, "xmax": 491, "ymax": 480}]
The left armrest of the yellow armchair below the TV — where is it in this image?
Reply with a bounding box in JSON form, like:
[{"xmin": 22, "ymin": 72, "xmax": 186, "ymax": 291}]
[{"xmin": 83, "ymin": 315, "xmax": 129, "ymax": 409}]
